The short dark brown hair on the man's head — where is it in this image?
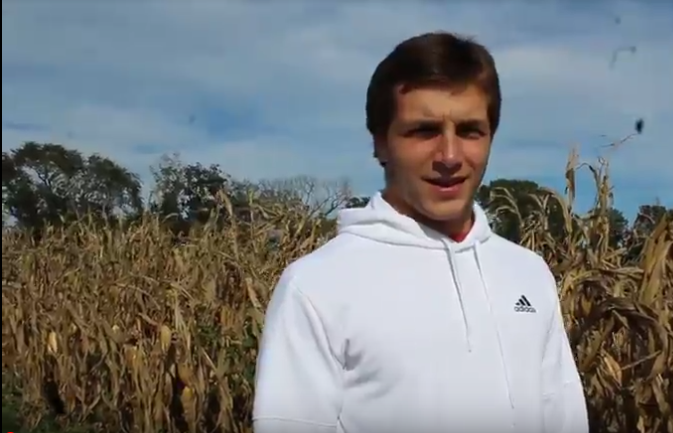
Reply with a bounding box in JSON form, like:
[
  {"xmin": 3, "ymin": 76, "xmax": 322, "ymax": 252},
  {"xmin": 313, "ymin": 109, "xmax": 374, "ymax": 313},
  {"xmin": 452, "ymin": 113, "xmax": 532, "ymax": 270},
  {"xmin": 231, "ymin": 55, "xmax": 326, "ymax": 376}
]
[{"xmin": 365, "ymin": 32, "xmax": 501, "ymax": 142}]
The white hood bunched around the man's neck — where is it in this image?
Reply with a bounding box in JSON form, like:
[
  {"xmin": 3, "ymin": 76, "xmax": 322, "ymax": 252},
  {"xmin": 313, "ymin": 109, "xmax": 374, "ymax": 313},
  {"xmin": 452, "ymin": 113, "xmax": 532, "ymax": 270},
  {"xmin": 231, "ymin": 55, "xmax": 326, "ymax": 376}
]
[{"xmin": 337, "ymin": 192, "xmax": 493, "ymax": 252}]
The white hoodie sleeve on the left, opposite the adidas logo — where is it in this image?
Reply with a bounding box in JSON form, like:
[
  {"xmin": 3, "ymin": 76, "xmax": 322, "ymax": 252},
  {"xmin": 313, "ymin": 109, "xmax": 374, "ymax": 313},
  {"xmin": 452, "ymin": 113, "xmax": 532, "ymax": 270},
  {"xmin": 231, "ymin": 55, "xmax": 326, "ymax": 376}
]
[{"xmin": 253, "ymin": 272, "xmax": 343, "ymax": 433}]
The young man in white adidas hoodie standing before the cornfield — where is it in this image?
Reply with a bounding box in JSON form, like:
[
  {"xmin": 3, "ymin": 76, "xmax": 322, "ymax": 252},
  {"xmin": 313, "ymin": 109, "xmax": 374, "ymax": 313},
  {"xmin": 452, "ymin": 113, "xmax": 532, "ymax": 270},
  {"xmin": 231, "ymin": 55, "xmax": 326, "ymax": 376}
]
[{"xmin": 253, "ymin": 33, "xmax": 588, "ymax": 433}]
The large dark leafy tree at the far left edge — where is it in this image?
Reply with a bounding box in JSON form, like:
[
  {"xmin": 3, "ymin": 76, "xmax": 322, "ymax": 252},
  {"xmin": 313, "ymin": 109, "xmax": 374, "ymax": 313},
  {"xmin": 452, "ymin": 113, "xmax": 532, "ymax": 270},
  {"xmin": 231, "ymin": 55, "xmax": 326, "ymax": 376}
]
[{"xmin": 2, "ymin": 142, "xmax": 142, "ymax": 228}]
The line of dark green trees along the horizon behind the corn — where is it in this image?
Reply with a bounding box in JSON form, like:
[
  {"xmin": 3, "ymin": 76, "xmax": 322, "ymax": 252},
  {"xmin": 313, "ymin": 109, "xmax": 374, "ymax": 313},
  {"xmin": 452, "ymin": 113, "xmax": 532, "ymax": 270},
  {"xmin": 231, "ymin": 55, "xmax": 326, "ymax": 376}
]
[{"xmin": 2, "ymin": 142, "xmax": 673, "ymax": 248}]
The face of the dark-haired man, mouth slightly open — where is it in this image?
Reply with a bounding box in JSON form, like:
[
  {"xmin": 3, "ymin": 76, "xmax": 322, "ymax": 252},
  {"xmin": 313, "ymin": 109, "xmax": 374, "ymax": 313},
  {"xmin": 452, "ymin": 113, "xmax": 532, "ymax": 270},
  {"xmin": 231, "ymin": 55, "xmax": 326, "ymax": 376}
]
[{"xmin": 375, "ymin": 82, "xmax": 491, "ymax": 228}]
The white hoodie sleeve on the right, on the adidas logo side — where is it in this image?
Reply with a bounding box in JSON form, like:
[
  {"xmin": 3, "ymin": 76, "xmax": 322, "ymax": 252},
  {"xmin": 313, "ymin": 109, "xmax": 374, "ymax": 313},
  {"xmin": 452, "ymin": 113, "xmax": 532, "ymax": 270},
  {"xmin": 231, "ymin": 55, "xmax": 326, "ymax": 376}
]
[{"xmin": 542, "ymin": 273, "xmax": 589, "ymax": 433}]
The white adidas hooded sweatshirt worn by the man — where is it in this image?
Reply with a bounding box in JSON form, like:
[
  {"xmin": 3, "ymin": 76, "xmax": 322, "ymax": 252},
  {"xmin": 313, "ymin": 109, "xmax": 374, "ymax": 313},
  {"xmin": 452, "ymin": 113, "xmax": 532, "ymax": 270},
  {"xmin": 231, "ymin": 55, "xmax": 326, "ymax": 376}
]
[{"xmin": 253, "ymin": 193, "xmax": 588, "ymax": 433}]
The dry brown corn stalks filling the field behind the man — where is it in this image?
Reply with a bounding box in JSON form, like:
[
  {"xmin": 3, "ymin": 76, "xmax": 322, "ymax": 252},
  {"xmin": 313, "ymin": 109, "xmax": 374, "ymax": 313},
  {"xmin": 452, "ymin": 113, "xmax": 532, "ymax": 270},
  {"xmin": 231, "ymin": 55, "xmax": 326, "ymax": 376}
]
[{"xmin": 2, "ymin": 149, "xmax": 673, "ymax": 433}]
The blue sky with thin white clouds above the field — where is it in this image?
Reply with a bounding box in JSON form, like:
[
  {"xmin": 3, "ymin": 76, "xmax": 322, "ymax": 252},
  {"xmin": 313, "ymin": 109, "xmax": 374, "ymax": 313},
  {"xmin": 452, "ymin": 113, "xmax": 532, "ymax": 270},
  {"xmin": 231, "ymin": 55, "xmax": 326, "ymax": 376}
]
[{"xmin": 2, "ymin": 0, "xmax": 673, "ymax": 216}]
